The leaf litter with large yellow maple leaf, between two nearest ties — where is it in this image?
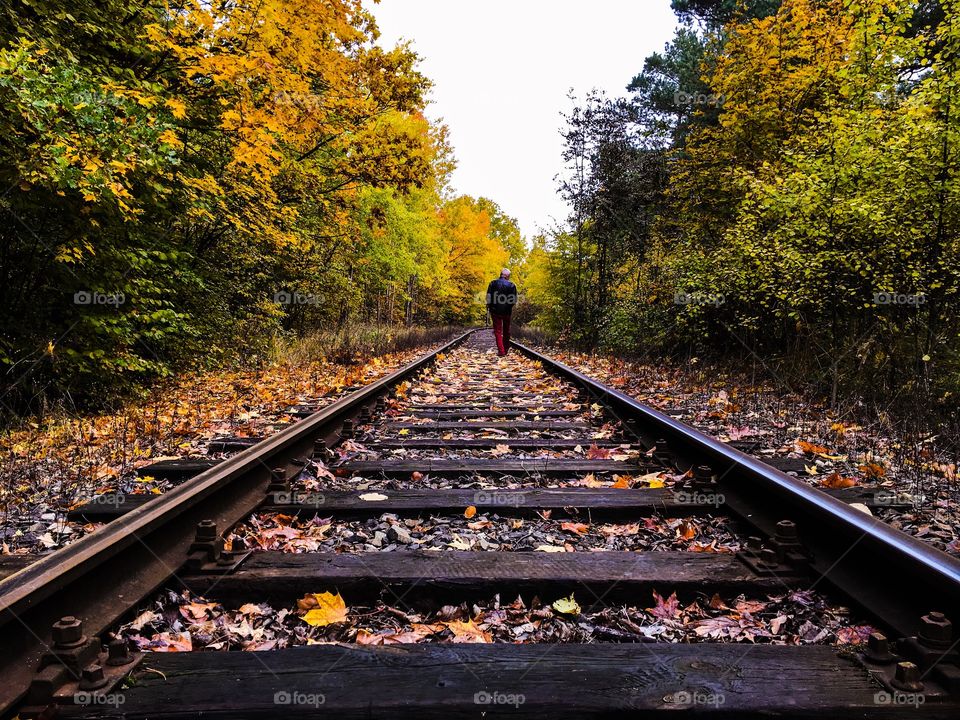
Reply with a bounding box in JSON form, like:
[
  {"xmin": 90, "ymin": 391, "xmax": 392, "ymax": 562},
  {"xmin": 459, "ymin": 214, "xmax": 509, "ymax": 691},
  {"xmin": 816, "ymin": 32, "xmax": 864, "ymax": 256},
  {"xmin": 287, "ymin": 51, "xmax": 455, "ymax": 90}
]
[{"xmin": 118, "ymin": 590, "xmax": 875, "ymax": 652}]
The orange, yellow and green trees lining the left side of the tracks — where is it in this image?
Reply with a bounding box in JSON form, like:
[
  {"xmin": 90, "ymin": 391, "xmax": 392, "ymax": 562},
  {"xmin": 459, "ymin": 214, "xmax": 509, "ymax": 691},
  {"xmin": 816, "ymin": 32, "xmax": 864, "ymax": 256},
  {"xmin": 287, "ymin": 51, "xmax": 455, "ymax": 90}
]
[{"xmin": 0, "ymin": 0, "xmax": 525, "ymax": 411}]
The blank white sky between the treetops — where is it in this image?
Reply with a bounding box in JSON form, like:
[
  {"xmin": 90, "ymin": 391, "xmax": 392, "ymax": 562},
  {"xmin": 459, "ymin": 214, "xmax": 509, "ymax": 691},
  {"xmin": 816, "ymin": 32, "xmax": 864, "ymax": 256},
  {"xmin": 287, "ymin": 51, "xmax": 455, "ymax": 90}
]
[{"xmin": 368, "ymin": 0, "xmax": 676, "ymax": 237}]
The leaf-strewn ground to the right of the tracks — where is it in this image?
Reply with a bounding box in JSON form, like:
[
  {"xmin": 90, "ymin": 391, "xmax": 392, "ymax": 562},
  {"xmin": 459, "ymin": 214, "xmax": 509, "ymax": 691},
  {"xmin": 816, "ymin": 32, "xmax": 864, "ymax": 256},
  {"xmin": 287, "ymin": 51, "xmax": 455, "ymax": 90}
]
[{"xmin": 545, "ymin": 349, "xmax": 960, "ymax": 555}]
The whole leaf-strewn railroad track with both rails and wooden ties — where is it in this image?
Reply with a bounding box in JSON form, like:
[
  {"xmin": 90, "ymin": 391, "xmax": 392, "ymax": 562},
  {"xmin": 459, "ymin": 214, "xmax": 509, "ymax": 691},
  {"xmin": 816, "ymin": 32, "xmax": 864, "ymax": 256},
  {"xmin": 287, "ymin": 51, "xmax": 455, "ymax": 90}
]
[{"xmin": 0, "ymin": 333, "xmax": 960, "ymax": 718}]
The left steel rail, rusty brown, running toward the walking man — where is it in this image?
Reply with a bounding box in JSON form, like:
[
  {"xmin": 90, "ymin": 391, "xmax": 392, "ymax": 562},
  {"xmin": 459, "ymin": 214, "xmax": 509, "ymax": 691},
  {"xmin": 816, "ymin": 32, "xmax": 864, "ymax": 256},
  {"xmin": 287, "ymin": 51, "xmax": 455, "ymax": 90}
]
[{"xmin": 0, "ymin": 330, "xmax": 474, "ymax": 713}]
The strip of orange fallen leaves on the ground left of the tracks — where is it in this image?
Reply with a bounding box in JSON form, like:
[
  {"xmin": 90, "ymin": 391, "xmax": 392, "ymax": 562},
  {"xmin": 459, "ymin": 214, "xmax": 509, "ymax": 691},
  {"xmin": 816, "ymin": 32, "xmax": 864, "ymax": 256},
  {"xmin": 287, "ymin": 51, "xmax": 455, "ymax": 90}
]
[{"xmin": 0, "ymin": 348, "xmax": 442, "ymax": 554}]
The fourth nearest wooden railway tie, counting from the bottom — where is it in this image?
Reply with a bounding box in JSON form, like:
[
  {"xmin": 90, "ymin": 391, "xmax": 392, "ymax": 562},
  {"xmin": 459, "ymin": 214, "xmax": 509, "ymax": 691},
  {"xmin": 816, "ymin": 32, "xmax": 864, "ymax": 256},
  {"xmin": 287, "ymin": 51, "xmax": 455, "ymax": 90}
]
[{"xmin": 336, "ymin": 458, "xmax": 652, "ymax": 477}]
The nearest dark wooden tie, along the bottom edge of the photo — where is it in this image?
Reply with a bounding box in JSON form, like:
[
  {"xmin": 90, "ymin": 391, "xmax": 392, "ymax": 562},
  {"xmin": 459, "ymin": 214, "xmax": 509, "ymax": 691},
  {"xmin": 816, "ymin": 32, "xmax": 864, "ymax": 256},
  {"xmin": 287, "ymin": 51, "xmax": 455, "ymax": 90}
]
[{"xmin": 61, "ymin": 643, "xmax": 920, "ymax": 720}]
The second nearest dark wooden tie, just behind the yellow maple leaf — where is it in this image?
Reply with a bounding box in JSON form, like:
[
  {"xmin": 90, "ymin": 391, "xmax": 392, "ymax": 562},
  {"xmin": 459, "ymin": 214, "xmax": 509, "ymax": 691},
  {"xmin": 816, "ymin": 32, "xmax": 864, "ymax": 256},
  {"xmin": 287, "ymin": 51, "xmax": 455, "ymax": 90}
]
[{"xmin": 179, "ymin": 550, "xmax": 796, "ymax": 607}]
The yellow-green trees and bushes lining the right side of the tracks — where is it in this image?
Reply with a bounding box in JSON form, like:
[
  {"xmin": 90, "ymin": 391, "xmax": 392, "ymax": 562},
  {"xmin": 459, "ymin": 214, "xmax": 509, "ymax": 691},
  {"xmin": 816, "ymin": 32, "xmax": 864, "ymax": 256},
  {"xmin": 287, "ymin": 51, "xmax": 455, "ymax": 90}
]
[{"xmin": 538, "ymin": 0, "xmax": 960, "ymax": 414}]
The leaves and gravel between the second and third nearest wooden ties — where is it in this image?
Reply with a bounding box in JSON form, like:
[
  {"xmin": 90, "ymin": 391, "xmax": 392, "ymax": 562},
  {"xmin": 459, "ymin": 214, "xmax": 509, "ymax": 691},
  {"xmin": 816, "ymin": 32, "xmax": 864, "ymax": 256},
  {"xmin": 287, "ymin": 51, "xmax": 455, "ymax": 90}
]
[{"xmin": 226, "ymin": 508, "xmax": 740, "ymax": 553}]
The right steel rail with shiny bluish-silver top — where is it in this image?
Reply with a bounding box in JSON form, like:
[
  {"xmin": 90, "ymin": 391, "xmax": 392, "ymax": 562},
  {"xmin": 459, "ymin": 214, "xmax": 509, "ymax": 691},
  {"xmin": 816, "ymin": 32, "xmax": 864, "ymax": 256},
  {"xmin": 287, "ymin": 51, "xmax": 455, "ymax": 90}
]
[{"xmin": 512, "ymin": 341, "xmax": 960, "ymax": 636}]
